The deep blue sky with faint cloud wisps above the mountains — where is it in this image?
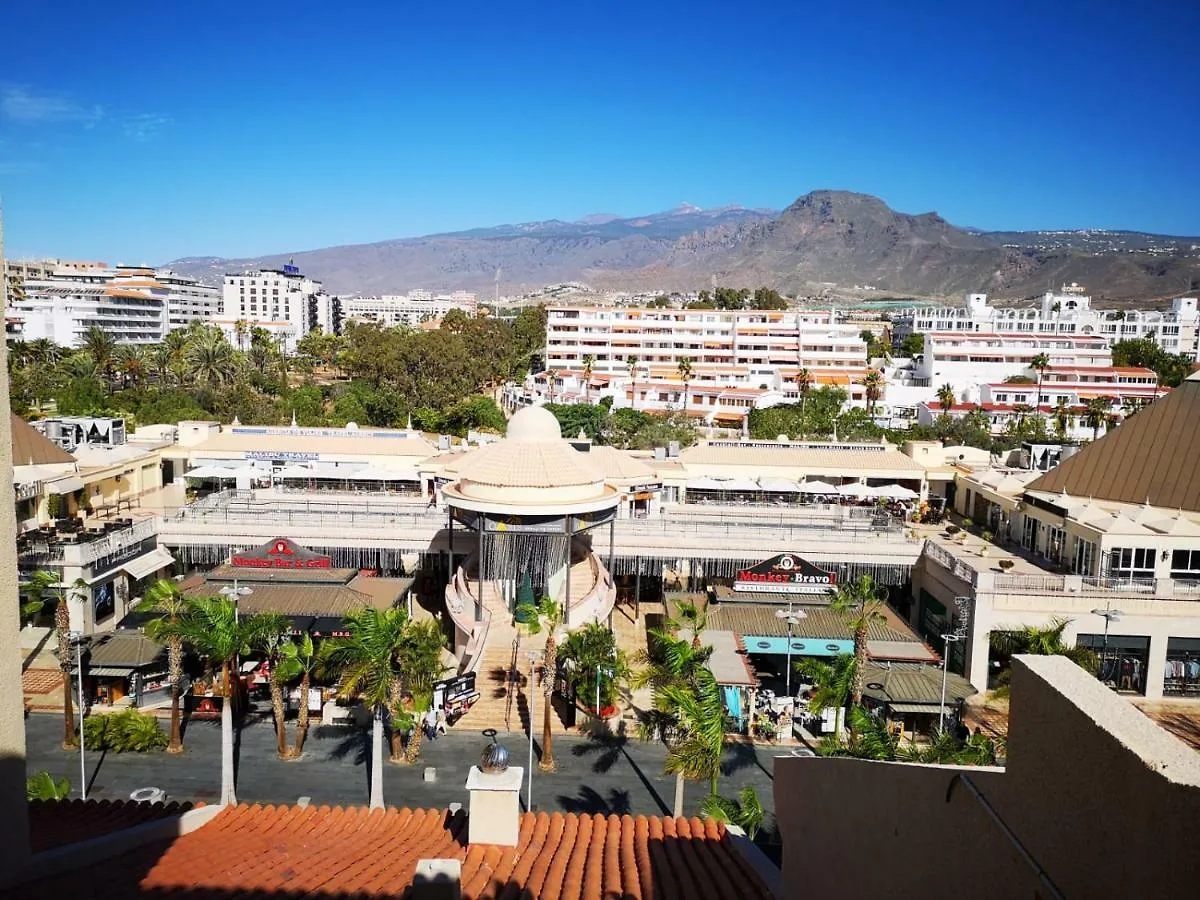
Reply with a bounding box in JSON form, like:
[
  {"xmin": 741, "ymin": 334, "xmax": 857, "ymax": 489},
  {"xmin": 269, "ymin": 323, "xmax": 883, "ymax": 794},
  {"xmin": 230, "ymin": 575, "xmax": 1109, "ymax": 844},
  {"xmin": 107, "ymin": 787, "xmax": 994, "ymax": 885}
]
[{"xmin": 0, "ymin": 0, "xmax": 1200, "ymax": 263}]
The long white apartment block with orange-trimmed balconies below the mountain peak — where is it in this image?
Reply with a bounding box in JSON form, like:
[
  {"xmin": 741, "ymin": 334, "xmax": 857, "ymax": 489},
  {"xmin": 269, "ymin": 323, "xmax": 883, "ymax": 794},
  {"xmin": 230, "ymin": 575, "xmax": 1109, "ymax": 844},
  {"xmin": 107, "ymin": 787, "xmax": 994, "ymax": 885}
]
[{"xmin": 546, "ymin": 306, "xmax": 866, "ymax": 416}]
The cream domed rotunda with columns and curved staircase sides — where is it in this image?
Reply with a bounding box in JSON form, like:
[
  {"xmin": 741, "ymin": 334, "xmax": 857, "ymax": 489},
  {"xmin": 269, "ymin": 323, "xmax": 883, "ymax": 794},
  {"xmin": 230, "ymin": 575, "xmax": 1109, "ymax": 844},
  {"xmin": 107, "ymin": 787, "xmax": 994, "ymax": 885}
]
[{"xmin": 442, "ymin": 407, "xmax": 620, "ymax": 672}]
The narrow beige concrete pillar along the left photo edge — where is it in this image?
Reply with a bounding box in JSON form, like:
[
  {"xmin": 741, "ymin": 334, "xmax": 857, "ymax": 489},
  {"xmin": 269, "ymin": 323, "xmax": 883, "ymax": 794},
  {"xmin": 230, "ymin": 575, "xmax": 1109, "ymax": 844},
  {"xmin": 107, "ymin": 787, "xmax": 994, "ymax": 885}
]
[{"xmin": 0, "ymin": 213, "xmax": 29, "ymax": 884}]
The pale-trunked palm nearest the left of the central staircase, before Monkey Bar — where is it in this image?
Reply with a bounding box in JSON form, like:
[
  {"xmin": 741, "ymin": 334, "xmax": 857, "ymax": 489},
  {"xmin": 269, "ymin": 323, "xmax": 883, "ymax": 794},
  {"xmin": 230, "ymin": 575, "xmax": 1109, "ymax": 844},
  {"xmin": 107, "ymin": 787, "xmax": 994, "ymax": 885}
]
[{"xmin": 317, "ymin": 606, "xmax": 417, "ymax": 809}]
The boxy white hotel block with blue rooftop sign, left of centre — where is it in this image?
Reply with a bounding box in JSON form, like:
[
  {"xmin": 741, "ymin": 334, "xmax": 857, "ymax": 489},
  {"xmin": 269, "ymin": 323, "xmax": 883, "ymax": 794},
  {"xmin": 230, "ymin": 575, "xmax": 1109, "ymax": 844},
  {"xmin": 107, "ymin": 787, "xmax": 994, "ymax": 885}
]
[{"xmin": 220, "ymin": 265, "xmax": 334, "ymax": 352}]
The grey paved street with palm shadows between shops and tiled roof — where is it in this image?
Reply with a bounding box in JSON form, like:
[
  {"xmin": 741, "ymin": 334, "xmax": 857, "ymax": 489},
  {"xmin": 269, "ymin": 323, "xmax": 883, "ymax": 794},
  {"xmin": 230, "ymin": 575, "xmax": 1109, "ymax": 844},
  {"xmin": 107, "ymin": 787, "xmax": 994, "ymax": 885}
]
[{"xmin": 25, "ymin": 713, "xmax": 787, "ymax": 844}]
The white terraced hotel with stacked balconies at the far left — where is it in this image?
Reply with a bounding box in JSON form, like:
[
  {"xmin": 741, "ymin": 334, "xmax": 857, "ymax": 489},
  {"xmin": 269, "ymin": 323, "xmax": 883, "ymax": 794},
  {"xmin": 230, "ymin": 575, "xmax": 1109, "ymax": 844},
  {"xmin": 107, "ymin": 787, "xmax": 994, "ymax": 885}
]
[{"xmin": 10, "ymin": 268, "xmax": 169, "ymax": 347}]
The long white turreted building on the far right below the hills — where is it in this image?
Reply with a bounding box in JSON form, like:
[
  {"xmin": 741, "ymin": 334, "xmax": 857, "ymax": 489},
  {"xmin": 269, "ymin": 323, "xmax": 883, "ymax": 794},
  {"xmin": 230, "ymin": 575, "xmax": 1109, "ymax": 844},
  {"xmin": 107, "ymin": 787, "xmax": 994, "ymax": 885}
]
[{"xmin": 895, "ymin": 284, "xmax": 1200, "ymax": 360}]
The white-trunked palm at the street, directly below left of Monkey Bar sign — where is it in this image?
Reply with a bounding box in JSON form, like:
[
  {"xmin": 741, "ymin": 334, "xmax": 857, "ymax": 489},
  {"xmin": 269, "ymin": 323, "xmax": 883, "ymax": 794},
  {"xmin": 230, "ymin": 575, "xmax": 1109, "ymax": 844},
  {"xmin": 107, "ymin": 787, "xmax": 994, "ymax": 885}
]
[{"xmin": 160, "ymin": 596, "xmax": 278, "ymax": 806}]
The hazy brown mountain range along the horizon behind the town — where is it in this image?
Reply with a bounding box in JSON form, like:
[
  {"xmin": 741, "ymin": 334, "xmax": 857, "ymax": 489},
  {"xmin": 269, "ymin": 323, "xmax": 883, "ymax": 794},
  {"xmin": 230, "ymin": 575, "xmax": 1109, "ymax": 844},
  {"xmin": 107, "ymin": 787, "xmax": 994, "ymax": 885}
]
[{"xmin": 169, "ymin": 191, "xmax": 1200, "ymax": 301}]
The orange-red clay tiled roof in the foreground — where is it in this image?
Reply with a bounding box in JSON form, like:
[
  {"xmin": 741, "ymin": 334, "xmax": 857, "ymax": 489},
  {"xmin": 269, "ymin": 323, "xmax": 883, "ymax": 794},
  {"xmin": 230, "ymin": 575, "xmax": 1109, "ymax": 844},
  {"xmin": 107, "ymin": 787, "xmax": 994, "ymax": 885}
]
[{"xmin": 13, "ymin": 805, "xmax": 772, "ymax": 900}]
